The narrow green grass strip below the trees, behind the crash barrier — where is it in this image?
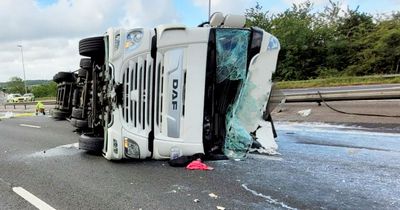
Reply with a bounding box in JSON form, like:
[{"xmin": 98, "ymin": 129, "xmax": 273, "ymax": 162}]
[{"xmin": 277, "ymin": 75, "xmax": 400, "ymax": 89}]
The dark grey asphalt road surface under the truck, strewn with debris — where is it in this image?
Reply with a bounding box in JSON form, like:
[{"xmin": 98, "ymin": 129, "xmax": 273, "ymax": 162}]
[{"xmin": 0, "ymin": 116, "xmax": 400, "ymax": 209}]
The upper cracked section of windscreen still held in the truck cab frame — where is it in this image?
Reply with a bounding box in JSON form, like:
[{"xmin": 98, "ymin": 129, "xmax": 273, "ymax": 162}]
[{"xmin": 216, "ymin": 29, "xmax": 250, "ymax": 83}]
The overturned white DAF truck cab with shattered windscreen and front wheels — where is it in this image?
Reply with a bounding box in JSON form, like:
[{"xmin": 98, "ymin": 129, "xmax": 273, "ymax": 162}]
[{"xmin": 64, "ymin": 13, "xmax": 280, "ymax": 160}]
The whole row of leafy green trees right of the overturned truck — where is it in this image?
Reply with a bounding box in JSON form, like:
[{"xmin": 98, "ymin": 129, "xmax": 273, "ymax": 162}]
[{"xmin": 245, "ymin": 0, "xmax": 400, "ymax": 80}]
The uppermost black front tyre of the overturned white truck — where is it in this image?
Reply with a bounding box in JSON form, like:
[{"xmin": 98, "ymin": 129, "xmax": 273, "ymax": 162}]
[{"xmin": 79, "ymin": 36, "xmax": 105, "ymax": 58}]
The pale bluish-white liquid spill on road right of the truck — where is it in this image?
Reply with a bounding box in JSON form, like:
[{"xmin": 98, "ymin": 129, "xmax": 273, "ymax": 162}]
[{"xmin": 275, "ymin": 122, "xmax": 400, "ymax": 152}]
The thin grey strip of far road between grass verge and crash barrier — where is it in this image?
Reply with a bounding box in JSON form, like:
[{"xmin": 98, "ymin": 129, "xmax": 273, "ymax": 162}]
[{"xmin": 282, "ymin": 84, "xmax": 400, "ymax": 95}]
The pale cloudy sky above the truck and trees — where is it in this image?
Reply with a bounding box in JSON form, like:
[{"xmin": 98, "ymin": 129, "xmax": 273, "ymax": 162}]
[{"xmin": 0, "ymin": 0, "xmax": 400, "ymax": 82}]
